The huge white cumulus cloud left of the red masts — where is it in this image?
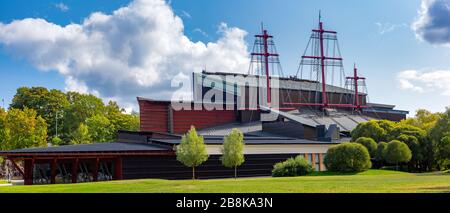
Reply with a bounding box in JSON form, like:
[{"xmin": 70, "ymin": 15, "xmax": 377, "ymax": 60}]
[{"xmin": 0, "ymin": 0, "xmax": 249, "ymax": 110}]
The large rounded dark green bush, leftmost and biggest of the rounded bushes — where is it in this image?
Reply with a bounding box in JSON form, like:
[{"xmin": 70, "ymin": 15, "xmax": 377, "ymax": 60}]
[{"xmin": 324, "ymin": 142, "xmax": 372, "ymax": 172}]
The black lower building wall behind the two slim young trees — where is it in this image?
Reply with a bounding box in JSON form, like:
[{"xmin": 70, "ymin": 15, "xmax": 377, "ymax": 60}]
[{"xmin": 122, "ymin": 154, "xmax": 298, "ymax": 179}]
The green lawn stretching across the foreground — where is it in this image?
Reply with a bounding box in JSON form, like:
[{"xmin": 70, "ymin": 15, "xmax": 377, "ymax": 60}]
[{"xmin": 0, "ymin": 170, "xmax": 450, "ymax": 193}]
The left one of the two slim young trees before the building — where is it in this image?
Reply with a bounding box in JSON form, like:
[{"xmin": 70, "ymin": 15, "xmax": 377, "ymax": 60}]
[{"xmin": 176, "ymin": 126, "xmax": 209, "ymax": 179}]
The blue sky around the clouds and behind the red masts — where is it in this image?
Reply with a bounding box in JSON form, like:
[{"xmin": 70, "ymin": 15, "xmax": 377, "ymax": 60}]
[{"xmin": 0, "ymin": 0, "xmax": 450, "ymax": 112}]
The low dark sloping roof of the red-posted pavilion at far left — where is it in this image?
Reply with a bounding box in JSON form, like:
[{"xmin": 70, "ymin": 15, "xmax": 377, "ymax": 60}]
[{"xmin": 0, "ymin": 142, "xmax": 171, "ymax": 155}]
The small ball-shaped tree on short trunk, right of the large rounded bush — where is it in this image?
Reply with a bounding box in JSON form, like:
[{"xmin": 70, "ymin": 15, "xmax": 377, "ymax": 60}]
[{"xmin": 383, "ymin": 140, "xmax": 412, "ymax": 170}]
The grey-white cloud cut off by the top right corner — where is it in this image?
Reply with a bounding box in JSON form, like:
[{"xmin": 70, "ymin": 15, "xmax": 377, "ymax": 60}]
[{"xmin": 412, "ymin": 0, "xmax": 450, "ymax": 46}]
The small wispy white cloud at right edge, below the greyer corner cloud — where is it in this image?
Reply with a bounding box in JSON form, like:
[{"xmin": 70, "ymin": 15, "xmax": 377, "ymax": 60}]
[{"xmin": 397, "ymin": 70, "xmax": 450, "ymax": 96}]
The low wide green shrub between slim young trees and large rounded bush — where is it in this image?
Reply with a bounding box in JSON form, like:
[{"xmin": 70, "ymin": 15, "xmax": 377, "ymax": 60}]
[{"xmin": 272, "ymin": 155, "xmax": 313, "ymax": 177}]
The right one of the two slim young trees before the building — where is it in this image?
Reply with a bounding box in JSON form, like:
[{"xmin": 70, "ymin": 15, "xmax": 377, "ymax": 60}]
[{"xmin": 220, "ymin": 129, "xmax": 245, "ymax": 178}]
